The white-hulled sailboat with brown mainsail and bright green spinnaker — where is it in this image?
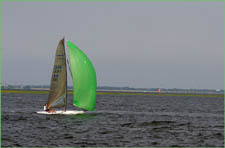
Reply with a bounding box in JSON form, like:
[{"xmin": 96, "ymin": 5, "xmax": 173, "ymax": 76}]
[{"xmin": 37, "ymin": 38, "xmax": 97, "ymax": 114}]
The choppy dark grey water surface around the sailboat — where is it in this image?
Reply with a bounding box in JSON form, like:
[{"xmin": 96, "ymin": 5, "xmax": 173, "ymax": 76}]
[{"xmin": 2, "ymin": 94, "xmax": 224, "ymax": 147}]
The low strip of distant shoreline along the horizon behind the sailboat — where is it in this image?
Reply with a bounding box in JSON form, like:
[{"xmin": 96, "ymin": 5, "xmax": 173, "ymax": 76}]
[{"xmin": 1, "ymin": 89, "xmax": 224, "ymax": 98}]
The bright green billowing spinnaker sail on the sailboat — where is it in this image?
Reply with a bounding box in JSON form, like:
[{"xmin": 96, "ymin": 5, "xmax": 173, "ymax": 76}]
[{"xmin": 67, "ymin": 41, "xmax": 97, "ymax": 111}]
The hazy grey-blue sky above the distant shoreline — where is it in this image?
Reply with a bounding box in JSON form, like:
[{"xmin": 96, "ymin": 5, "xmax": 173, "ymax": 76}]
[{"xmin": 1, "ymin": 1, "xmax": 224, "ymax": 89}]
